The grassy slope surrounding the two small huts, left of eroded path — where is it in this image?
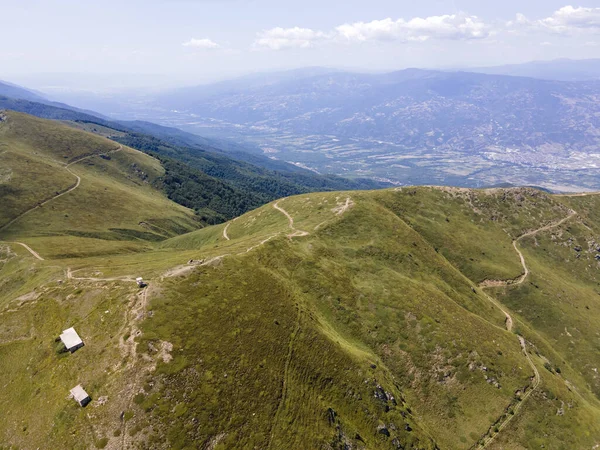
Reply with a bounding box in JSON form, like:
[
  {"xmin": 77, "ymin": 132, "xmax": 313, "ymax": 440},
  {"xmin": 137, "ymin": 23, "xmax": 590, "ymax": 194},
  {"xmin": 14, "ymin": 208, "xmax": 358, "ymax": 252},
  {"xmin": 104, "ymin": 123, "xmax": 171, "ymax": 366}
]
[{"xmin": 0, "ymin": 276, "xmax": 137, "ymax": 448}]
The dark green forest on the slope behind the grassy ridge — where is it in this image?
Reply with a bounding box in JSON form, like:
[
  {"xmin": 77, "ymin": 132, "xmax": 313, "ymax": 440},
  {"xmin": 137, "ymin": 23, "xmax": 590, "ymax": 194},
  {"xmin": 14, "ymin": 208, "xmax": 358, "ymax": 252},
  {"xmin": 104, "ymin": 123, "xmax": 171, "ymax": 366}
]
[{"xmin": 114, "ymin": 133, "xmax": 383, "ymax": 224}]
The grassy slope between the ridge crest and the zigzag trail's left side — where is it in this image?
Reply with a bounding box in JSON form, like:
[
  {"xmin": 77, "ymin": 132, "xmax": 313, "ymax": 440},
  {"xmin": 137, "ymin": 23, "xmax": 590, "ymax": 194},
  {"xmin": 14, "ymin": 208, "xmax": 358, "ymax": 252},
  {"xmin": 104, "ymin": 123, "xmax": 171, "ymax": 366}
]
[{"xmin": 377, "ymin": 188, "xmax": 568, "ymax": 282}]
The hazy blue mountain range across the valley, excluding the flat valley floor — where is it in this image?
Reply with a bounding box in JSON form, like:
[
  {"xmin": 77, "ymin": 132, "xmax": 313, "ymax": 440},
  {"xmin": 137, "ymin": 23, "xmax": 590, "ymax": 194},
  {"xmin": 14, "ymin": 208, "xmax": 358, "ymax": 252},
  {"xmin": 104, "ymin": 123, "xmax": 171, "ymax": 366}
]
[{"xmin": 155, "ymin": 69, "xmax": 600, "ymax": 151}]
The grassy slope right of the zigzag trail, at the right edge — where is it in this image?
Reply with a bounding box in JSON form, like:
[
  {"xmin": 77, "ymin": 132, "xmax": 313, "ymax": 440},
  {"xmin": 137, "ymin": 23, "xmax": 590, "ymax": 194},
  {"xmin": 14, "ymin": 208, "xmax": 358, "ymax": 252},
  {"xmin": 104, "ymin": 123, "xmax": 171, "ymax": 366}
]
[{"xmin": 490, "ymin": 223, "xmax": 600, "ymax": 396}]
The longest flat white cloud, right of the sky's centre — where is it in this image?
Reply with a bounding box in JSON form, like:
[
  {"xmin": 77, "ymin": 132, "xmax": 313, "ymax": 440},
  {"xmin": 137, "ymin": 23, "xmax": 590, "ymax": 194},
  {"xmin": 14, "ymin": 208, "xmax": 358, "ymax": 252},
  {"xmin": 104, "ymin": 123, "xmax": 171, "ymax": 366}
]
[{"xmin": 336, "ymin": 14, "xmax": 491, "ymax": 42}]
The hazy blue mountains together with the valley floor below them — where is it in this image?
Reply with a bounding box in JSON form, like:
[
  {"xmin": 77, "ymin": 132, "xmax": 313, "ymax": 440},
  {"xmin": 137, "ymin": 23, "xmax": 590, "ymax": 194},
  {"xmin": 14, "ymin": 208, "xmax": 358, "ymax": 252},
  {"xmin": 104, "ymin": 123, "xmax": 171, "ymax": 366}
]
[{"xmin": 5, "ymin": 60, "xmax": 600, "ymax": 191}]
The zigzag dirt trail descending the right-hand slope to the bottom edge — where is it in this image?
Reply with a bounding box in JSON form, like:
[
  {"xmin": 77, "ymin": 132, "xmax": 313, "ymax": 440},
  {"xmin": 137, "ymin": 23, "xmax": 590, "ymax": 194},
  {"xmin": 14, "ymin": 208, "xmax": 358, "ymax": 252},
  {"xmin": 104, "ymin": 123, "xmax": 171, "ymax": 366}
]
[{"xmin": 476, "ymin": 210, "xmax": 577, "ymax": 448}]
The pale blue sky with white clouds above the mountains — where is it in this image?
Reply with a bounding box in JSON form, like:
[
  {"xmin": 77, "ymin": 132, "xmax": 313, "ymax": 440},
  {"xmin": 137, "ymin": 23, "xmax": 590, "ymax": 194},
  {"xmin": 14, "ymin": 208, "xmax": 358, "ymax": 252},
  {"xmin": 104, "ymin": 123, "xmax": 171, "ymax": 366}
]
[{"xmin": 0, "ymin": 0, "xmax": 600, "ymax": 89}]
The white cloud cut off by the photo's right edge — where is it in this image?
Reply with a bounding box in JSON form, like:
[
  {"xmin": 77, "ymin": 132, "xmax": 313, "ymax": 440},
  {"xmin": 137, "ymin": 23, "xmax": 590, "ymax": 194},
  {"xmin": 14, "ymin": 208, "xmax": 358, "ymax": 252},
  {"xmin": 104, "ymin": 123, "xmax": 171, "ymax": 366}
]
[{"xmin": 506, "ymin": 5, "xmax": 600, "ymax": 34}]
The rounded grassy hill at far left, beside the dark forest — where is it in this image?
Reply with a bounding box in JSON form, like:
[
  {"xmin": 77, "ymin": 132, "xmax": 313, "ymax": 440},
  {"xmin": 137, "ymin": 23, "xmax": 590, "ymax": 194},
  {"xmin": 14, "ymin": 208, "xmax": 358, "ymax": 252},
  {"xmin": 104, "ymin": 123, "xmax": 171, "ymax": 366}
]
[{"xmin": 0, "ymin": 112, "xmax": 199, "ymax": 257}]
